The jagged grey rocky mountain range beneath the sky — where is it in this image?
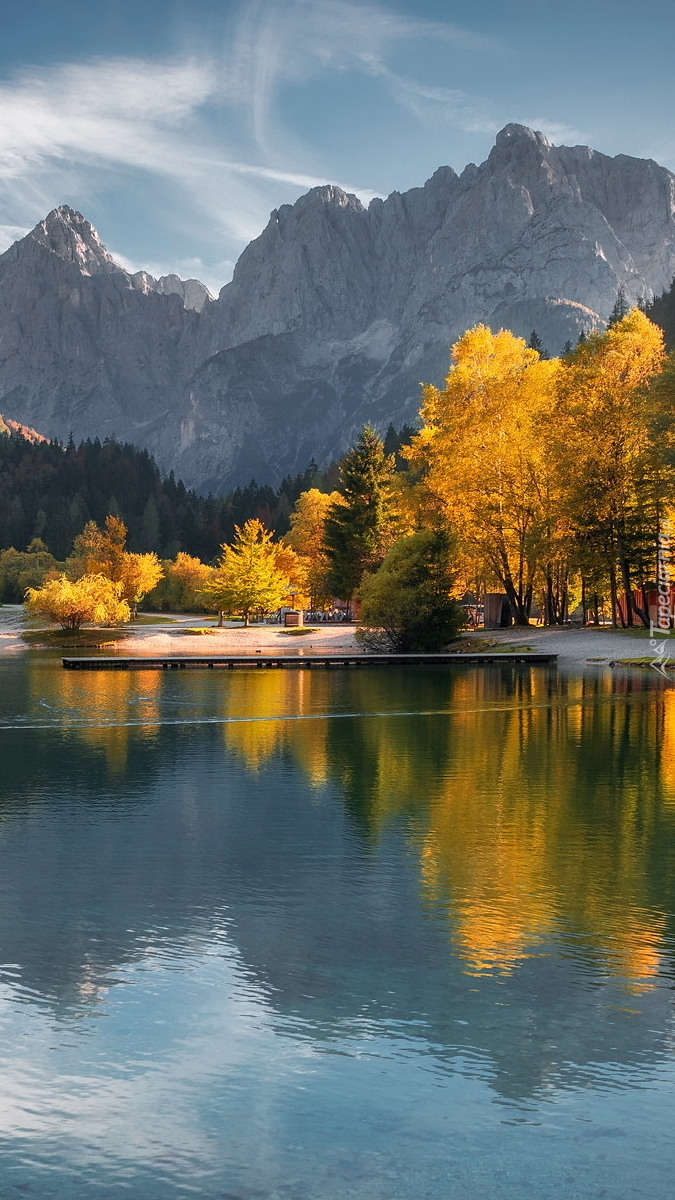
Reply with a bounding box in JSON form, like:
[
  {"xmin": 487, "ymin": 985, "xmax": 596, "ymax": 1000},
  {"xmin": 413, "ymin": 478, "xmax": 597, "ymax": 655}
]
[{"xmin": 0, "ymin": 125, "xmax": 675, "ymax": 490}]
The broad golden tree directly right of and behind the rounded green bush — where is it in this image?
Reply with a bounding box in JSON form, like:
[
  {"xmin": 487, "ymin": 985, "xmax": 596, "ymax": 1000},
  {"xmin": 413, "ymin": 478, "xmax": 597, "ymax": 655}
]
[{"xmin": 407, "ymin": 325, "xmax": 557, "ymax": 625}]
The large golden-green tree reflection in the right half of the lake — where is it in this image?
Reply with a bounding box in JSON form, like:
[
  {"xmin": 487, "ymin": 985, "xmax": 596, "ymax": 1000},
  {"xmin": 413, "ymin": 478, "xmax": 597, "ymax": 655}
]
[{"xmin": 263, "ymin": 667, "xmax": 675, "ymax": 992}]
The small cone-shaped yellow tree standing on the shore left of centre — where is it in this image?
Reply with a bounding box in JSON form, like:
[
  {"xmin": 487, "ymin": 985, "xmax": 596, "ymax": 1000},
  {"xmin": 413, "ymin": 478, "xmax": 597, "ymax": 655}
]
[{"xmin": 202, "ymin": 520, "xmax": 291, "ymax": 625}]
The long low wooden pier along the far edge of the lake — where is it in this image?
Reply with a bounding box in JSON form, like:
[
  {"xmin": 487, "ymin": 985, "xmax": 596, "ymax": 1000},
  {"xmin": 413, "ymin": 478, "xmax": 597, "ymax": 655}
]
[{"xmin": 61, "ymin": 652, "xmax": 557, "ymax": 671}]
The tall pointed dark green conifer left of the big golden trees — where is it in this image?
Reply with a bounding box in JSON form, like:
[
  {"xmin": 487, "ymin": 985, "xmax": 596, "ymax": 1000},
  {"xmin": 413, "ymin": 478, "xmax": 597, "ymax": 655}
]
[{"xmin": 323, "ymin": 425, "xmax": 394, "ymax": 600}]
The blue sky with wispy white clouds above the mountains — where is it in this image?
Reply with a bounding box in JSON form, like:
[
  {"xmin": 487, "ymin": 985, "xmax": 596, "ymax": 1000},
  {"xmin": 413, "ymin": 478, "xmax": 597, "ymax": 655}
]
[{"xmin": 0, "ymin": 0, "xmax": 675, "ymax": 293}]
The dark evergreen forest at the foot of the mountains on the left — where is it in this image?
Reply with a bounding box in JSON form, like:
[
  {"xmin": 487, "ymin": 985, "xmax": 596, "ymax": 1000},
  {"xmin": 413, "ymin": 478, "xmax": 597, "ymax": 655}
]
[{"xmin": 0, "ymin": 426, "xmax": 414, "ymax": 563}]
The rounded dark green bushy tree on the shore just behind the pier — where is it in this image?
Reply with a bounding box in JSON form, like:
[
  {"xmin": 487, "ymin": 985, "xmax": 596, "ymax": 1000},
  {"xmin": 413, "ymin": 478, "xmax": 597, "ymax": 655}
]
[{"xmin": 358, "ymin": 529, "xmax": 465, "ymax": 652}]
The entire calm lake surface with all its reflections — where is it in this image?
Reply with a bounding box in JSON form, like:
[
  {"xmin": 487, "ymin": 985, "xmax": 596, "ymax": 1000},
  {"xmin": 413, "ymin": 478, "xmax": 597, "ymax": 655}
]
[{"xmin": 0, "ymin": 652, "xmax": 675, "ymax": 1200}]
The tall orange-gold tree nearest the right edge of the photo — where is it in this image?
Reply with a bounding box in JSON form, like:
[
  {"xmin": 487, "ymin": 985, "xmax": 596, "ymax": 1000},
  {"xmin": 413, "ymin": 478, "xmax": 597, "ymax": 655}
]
[{"xmin": 550, "ymin": 308, "xmax": 674, "ymax": 625}]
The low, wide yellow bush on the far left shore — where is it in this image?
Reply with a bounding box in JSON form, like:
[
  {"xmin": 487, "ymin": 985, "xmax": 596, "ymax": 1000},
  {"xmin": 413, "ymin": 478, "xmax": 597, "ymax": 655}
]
[{"xmin": 25, "ymin": 575, "xmax": 131, "ymax": 629}]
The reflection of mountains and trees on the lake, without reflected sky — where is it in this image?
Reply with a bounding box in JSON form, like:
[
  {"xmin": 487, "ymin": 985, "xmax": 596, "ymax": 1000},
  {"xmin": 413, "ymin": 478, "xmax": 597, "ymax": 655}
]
[{"xmin": 0, "ymin": 658, "xmax": 675, "ymax": 1100}]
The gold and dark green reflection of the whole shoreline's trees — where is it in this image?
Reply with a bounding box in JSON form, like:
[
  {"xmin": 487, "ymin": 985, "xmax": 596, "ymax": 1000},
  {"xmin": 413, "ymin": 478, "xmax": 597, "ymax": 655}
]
[{"xmin": 5, "ymin": 660, "xmax": 675, "ymax": 994}]
